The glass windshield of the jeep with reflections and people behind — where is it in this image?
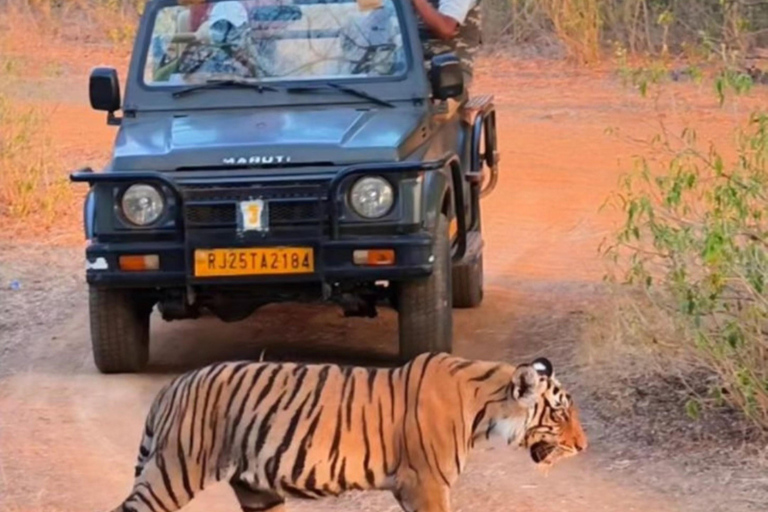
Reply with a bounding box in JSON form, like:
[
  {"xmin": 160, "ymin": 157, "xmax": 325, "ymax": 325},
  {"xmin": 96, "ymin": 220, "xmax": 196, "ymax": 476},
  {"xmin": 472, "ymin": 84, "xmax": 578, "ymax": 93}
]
[{"xmin": 144, "ymin": 0, "xmax": 406, "ymax": 87}]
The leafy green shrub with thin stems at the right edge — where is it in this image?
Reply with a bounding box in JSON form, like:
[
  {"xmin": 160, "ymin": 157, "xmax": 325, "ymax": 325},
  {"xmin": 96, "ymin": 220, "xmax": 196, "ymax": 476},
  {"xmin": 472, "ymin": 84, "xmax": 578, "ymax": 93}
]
[{"xmin": 605, "ymin": 90, "xmax": 768, "ymax": 428}]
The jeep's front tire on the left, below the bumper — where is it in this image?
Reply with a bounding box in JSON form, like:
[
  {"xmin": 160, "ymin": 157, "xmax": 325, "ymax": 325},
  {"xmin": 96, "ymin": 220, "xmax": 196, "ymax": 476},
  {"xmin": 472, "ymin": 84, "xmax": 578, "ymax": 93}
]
[{"xmin": 88, "ymin": 286, "xmax": 151, "ymax": 373}]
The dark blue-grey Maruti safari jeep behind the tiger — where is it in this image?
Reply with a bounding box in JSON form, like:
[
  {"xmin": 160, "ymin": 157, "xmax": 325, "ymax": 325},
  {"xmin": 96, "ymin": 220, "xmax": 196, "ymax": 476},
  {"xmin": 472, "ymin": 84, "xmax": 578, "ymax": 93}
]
[{"xmin": 71, "ymin": 0, "xmax": 498, "ymax": 373}]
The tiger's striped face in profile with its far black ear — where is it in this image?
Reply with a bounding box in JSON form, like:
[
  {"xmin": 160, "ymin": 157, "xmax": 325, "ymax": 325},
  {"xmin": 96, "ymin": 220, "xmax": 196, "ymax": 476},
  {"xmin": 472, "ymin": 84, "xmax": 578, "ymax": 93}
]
[{"xmin": 521, "ymin": 358, "xmax": 587, "ymax": 466}]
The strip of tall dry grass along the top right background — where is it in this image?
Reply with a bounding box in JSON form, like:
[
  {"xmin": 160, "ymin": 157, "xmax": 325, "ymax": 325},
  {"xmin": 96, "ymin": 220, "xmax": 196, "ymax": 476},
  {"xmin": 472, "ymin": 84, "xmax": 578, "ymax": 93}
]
[{"xmin": 484, "ymin": 0, "xmax": 768, "ymax": 64}]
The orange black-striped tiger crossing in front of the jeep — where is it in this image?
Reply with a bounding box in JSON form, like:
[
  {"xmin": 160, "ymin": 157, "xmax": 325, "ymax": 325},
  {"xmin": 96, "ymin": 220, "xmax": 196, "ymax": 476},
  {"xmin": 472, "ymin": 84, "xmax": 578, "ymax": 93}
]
[{"xmin": 108, "ymin": 353, "xmax": 587, "ymax": 512}]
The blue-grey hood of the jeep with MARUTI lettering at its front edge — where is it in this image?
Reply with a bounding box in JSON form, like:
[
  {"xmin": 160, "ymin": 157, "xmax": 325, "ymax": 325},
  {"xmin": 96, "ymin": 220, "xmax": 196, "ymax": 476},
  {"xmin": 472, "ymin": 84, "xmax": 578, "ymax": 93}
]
[{"xmin": 113, "ymin": 108, "xmax": 424, "ymax": 171}]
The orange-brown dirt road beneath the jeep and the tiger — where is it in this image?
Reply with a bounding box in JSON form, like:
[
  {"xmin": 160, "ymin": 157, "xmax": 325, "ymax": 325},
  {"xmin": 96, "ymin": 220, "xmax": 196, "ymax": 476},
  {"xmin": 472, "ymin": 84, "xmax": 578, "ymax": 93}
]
[{"xmin": 0, "ymin": 59, "xmax": 759, "ymax": 512}]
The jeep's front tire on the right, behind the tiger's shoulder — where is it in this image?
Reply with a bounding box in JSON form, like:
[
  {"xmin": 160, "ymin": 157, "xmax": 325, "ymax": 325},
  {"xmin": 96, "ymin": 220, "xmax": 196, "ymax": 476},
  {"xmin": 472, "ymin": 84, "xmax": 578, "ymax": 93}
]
[{"xmin": 397, "ymin": 215, "xmax": 453, "ymax": 361}]
